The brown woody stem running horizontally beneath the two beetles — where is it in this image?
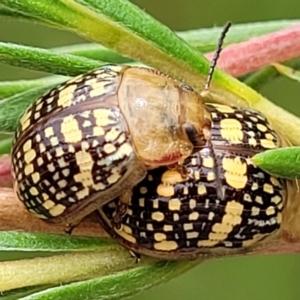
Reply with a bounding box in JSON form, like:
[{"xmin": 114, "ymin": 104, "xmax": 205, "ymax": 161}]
[{"xmin": 0, "ymin": 178, "xmax": 300, "ymax": 255}]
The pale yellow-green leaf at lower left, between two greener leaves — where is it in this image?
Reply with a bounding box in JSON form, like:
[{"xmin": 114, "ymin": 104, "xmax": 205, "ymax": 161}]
[{"xmin": 0, "ymin": 247, "xmax": 153, "ymax": 291}]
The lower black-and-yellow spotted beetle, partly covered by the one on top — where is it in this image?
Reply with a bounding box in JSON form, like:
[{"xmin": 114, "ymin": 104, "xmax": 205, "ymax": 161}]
[{"xmin": 99, "ymin": 104, "xmax": 287, "ymax": 259}]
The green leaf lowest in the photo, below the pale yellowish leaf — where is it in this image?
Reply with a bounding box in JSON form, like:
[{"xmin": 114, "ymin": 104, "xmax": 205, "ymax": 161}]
[{"xmin": 20, "ymin": 261, "xmax": 199, "ymax": 300}]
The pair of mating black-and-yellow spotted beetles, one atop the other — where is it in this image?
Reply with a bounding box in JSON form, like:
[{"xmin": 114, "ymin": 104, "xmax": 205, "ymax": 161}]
[{"xmin": 12, "ymin": 23, "xmax": 286, "ymax": 259}]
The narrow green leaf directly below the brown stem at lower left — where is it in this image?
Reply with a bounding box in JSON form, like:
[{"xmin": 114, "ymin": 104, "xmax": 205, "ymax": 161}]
[{"xmin": 0, "ymin": 231, "xmax": 118, "ymax": 252}]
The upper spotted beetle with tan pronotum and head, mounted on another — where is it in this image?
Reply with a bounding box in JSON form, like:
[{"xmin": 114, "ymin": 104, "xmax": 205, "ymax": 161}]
[{"xmin": 12, "ymin": 66, "xmax": 205, "ymax": 225}]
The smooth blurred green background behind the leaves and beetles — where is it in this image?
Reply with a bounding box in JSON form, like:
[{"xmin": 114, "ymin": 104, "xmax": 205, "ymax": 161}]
[{"xmin": 0, "ymin": 0, "xmax": 300, "ymax": 300}]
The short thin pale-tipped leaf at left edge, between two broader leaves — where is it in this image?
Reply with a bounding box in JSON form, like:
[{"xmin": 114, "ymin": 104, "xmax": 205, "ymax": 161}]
[{"xmin": 0, "ymin": 76, "xmax": 68, "ymax": 100}]
